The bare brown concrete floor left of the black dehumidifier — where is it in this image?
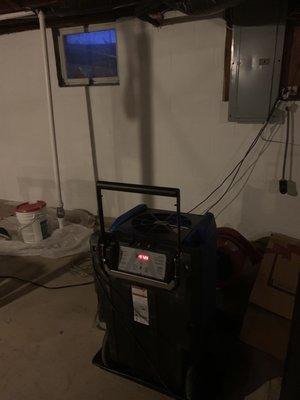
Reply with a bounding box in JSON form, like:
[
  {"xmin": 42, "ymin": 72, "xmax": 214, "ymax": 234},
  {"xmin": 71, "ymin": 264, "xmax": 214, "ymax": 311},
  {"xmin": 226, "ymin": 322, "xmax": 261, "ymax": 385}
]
[{"xmin": 0, "ymin": 257, "xmax": 167, "ymax": 400}]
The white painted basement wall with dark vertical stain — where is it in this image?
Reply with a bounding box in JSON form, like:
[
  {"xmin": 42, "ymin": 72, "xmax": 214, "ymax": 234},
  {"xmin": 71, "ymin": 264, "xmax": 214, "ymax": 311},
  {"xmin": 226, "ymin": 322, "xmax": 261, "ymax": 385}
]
[{"xmin": 0, "ymin": 20, "xmax": 300, "ymax": 238}]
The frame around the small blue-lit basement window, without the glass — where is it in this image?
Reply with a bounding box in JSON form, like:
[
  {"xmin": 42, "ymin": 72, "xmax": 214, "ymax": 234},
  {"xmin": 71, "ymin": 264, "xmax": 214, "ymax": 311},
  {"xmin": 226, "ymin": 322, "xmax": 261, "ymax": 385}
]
[{"xmin": 52, "ymin": 23, "xmax": 120, "ymax": 87}]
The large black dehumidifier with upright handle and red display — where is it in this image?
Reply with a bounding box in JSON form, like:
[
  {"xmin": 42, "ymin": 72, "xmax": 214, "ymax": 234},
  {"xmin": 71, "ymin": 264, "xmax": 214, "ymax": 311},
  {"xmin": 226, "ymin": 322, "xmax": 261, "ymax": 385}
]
[{"xmin": 91, "ymin": 181, "xmax": 216, "ymax": 400}]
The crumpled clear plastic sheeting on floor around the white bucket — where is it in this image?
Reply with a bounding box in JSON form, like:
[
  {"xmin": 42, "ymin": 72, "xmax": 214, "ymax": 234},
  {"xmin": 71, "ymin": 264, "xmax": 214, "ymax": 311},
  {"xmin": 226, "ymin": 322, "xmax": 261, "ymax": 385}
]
[{"xmin": 0, "ymin": 209, "xmax": 95, "ymax": 258}]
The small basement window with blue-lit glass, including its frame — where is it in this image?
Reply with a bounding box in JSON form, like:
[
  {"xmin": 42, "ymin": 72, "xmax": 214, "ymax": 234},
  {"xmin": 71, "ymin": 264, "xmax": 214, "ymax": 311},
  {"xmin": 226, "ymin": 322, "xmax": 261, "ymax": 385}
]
[{"xmin": 53, "ymin": 25, "xmax": 119, "ymax": 86}]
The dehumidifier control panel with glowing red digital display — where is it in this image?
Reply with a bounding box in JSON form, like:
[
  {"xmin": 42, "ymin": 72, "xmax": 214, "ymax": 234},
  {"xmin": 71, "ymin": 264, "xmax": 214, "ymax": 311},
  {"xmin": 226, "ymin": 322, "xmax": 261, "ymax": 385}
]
[{"xmin": 118, "ymin": 246, "xmax": 167, "ymax": 281}]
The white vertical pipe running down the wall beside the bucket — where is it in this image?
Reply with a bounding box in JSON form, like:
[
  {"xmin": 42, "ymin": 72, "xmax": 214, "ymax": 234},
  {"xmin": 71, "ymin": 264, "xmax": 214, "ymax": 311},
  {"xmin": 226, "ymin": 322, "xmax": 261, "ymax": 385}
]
[{"xmin": 38, "ymin": 10, "xmax": 64, "ymax": 228}]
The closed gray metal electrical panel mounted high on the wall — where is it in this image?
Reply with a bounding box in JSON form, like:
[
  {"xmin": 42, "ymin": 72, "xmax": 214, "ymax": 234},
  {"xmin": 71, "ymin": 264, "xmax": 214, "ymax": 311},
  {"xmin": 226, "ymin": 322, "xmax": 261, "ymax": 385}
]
[{"xmin": 228, "ymin": 25, "xmax": 285, "ymax": 123}]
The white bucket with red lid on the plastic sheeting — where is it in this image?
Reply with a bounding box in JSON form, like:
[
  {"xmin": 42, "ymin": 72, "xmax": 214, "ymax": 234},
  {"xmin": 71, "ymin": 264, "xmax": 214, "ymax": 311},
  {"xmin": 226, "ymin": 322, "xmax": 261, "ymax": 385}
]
[{"xmin": 16, "ymin": 201, "xmax": 48, "ymax": 243}]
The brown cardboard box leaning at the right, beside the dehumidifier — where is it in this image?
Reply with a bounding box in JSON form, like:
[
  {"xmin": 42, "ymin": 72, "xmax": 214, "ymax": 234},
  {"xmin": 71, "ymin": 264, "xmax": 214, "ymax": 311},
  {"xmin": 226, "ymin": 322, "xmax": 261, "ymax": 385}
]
[{"xmin": 241, "ymin": 234, "xmax": 300, "ymax": 360}]
